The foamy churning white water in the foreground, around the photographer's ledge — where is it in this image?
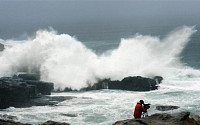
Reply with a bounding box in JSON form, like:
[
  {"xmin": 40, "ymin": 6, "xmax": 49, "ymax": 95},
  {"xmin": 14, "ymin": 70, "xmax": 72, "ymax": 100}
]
[{"xmin": 1, "ymin": 88, "xmax": 200, "ymax": 125}]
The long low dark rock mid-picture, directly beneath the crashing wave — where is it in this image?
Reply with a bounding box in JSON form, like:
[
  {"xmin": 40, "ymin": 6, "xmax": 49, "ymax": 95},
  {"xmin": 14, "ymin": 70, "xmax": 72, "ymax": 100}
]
[{"xmin": 81, "ymin": 76, "xmax": 162, "ymax": 91}]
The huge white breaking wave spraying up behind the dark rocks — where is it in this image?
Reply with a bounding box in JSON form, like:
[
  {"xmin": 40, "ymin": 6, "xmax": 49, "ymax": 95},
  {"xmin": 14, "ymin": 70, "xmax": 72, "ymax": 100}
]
[{"xmin": 0, "ymin": 26, "xmax": 200, "ymax": 89}]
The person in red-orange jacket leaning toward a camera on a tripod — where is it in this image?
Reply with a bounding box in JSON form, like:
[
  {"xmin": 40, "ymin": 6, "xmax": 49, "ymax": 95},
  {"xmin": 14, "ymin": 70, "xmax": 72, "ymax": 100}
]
[{"xmin": 133, "ymin": 100, "xmax": 147, "ymax": 119}]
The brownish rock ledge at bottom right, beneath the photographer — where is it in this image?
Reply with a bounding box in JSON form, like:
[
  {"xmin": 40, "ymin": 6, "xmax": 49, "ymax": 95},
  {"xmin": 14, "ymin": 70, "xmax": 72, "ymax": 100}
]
[{"xmin": 113, "ymin": 112, "xmax": 200, "ymax": 125}]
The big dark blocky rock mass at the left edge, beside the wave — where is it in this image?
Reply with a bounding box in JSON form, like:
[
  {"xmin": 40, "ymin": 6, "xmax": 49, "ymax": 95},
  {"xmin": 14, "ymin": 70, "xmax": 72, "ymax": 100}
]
[{"xmin": 0, "ymin": 73, "xmax": 53, "ymax": 109}]
